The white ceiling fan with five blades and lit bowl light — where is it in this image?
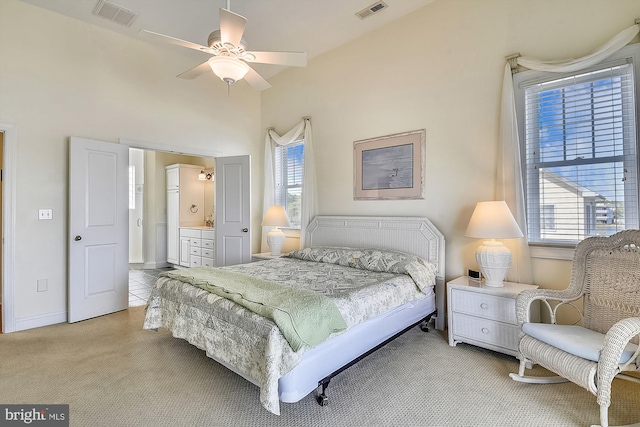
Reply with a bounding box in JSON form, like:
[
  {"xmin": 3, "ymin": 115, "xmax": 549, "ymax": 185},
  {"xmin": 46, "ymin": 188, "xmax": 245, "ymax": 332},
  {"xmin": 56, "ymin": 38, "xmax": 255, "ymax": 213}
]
[{"xmin": 139, "ymin": 0, "xmax": 307, "ymax": 90}]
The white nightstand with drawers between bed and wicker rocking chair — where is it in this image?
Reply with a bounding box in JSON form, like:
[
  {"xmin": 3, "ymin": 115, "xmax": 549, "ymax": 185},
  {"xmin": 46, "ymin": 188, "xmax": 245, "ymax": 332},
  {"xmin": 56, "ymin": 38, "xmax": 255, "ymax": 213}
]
[{"xmin": 447, "ymin": 276, "xmax": 539, "ymax": 357}]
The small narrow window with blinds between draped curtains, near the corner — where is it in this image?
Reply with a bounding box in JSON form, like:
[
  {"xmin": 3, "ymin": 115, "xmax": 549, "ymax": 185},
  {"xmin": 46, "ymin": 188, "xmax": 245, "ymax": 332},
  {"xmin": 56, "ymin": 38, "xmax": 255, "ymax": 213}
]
[{"xmin": 274, "ymin": 140, "xmax": 304, "ymax": 228}]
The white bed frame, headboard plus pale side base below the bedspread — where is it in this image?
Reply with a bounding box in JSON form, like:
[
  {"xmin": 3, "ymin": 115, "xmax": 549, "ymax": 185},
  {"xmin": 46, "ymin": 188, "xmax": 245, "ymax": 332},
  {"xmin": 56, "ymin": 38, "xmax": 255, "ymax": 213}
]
[{"xmin": 278, "ymin": 216, "xmax": 445, "ymax": 405}]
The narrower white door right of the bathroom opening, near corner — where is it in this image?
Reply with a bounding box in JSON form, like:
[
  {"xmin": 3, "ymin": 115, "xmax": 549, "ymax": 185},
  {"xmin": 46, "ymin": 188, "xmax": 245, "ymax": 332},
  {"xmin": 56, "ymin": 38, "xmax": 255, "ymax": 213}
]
[{"xmin": 214, "ymin": 156, "xmax": 251, "ymax": 267}]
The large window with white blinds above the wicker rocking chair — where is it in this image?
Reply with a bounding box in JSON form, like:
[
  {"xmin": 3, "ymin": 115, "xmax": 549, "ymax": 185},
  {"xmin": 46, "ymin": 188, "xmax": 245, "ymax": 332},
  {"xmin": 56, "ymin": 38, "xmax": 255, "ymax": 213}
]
[{"xmin": 514, "ymin": 47, "xmax": 640, "ymax": 245}]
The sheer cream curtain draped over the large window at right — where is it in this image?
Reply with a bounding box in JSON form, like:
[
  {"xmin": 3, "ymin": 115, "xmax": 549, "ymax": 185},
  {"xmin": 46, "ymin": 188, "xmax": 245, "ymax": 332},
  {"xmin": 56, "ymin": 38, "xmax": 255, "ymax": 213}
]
[{"xmin": 496, "ymin": 24, "xmax": 640, "ymax": 283}]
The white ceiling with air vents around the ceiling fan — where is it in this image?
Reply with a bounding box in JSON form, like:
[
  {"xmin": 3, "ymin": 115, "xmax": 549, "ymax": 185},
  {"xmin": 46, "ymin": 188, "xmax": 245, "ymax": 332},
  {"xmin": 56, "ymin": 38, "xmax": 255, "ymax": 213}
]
[{"xmin": 22, "ymin": 0, "xmax": 434, "ymax": 79}]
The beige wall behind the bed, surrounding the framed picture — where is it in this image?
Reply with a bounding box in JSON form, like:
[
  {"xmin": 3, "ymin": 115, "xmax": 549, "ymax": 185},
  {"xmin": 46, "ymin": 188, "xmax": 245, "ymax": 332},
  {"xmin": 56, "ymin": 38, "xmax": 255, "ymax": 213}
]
[{"xmin": 261, "ymin": 0, "xmax": 640, "ymax": 294}]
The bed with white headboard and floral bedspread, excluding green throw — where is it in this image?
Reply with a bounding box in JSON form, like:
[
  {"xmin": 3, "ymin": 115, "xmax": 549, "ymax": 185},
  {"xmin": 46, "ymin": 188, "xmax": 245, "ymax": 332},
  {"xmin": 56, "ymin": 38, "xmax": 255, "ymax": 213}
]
[{"xmin": 143, "ymin": 216, "xmax": 445, "ymax": 414}]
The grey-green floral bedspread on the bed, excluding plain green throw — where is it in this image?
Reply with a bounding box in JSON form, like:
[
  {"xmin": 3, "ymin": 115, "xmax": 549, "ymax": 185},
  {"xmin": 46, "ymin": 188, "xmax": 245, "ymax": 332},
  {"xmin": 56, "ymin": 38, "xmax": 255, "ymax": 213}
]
[{"xmin": 143, "ymin": 249, "xmax": 435, "ymax": 414}]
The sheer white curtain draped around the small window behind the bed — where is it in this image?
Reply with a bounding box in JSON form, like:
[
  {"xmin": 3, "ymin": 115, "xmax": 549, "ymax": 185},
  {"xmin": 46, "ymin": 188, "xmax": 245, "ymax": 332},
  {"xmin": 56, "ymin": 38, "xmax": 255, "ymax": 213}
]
[{"xmin": 262, "ymin": 117, "xmax": 317, "ymax": 247}]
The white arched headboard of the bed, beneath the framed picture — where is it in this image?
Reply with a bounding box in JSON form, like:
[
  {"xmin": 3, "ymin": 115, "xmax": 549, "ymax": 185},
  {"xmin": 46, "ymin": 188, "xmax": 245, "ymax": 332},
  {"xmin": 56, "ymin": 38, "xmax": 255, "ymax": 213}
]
[{"xmin": 305, "ymin": 215, "xmax": 445, "ymax": 330}]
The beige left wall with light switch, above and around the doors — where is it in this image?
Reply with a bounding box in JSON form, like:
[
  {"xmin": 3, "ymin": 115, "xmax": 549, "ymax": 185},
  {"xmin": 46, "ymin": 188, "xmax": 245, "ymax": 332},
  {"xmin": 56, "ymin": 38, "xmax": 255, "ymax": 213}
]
[{"xmin": 0, "ymin": 0, "xmax": 262, "ymax": 324}]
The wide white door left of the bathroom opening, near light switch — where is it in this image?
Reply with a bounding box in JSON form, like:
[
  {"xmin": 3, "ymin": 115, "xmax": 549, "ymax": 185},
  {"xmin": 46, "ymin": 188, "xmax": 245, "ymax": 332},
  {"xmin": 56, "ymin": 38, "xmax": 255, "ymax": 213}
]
[{"xmin": 68, "ymin": 137, "xmax": 129, "ymax": 323}]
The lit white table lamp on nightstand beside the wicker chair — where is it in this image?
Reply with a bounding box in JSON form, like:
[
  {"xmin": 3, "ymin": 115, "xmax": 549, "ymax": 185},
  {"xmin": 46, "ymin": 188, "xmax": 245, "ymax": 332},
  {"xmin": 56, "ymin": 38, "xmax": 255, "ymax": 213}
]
[{"xmin": 464, "ymin": 200, "xmax": 523, "ymax": 287}]
